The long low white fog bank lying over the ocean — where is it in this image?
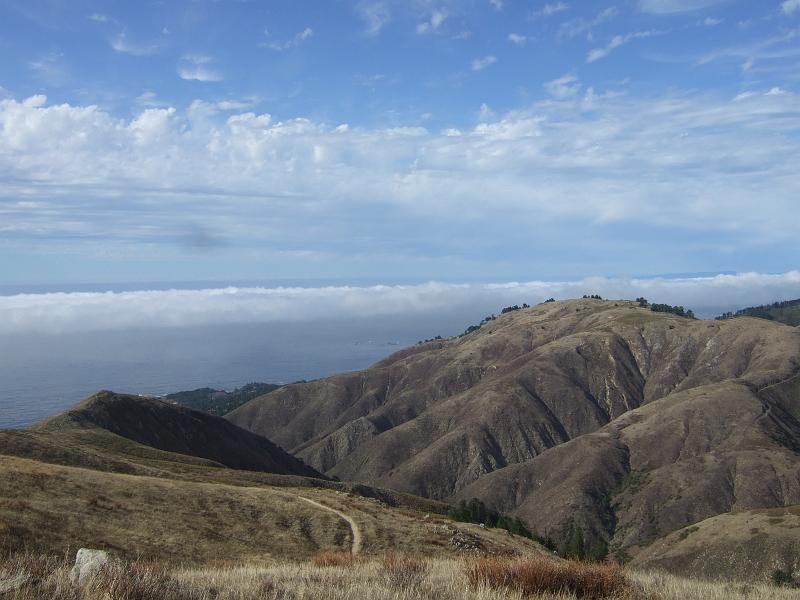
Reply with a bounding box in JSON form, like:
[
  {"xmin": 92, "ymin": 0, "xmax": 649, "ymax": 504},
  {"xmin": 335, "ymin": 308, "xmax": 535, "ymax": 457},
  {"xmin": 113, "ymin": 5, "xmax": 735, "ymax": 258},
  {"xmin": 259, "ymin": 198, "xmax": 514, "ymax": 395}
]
[{"xmin": 0, "ymin": 271, "xmax": 800, "ymax": 334}]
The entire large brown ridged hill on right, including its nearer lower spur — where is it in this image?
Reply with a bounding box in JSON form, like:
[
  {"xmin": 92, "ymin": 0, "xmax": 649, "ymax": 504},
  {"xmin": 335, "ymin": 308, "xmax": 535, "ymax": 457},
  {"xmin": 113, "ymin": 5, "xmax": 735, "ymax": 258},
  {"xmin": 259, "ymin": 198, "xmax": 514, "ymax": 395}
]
[{"xmin": 227, "ymin": 298, "xmax": 800, "ymax": 576}]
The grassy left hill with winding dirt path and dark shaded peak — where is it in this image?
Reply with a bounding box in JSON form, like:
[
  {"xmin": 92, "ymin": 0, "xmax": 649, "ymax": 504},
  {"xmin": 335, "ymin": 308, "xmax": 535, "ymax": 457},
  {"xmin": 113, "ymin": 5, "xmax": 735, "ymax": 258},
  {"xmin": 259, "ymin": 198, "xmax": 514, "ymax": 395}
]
[{"xmin": 0, "ymin": 392, "xmax": 542, "ymax": 565}]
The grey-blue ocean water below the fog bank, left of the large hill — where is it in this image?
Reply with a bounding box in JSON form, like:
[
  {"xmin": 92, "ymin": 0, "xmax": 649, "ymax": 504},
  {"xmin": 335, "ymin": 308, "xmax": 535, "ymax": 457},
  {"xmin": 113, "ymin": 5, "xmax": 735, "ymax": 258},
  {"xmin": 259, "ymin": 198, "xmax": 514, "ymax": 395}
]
[{"xmin": 0, "ymin": 315, "xmax": 463, "ymax": 428}]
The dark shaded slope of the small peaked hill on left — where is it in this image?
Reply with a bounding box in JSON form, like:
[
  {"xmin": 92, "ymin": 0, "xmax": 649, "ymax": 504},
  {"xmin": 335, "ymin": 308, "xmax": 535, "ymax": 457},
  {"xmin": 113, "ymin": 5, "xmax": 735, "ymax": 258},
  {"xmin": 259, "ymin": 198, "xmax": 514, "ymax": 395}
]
[{"xmin": 32, "ymin": 391, "xmax": 321, "ymax": 477}]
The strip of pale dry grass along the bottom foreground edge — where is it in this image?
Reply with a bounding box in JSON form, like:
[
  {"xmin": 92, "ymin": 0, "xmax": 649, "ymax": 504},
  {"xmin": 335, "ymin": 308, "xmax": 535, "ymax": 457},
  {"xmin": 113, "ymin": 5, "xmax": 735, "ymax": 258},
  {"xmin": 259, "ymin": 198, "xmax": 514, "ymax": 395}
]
[{"xmin": 0, "ymin": 554, "xmax": 798, "ymax": 600}]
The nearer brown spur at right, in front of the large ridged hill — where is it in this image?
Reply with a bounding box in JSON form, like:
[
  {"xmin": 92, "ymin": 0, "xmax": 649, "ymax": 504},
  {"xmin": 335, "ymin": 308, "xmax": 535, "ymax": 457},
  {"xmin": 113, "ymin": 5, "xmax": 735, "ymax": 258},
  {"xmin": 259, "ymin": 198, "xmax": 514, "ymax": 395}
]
[{"xmin": 459, "ymin": 382, "xmax": 800, "ymax": 558}]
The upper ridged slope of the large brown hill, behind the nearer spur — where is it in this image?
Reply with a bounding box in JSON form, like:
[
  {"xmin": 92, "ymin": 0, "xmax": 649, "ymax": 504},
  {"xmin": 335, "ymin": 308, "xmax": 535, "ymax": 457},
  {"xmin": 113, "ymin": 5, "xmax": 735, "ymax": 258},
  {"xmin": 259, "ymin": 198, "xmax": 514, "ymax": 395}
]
[{"xmin": 227, "ymin": 299, "xmax": 800, "ymax": 498}]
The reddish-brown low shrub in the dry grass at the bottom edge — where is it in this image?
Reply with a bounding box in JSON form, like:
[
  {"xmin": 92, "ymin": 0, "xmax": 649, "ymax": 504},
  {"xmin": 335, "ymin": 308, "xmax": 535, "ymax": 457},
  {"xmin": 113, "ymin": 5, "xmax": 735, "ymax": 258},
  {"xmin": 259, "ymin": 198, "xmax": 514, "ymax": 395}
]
[{"xmin": 467, "ymin": 557, "xmax": 630, "ymax": 599}]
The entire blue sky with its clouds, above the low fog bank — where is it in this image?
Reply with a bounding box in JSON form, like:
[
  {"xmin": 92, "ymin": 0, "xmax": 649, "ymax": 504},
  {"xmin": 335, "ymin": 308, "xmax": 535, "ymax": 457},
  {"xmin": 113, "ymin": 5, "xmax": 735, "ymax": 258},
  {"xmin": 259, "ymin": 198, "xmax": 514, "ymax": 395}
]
[{"xmin": 0, "ymin": 0, "xmax": 800, "ymax": 284}]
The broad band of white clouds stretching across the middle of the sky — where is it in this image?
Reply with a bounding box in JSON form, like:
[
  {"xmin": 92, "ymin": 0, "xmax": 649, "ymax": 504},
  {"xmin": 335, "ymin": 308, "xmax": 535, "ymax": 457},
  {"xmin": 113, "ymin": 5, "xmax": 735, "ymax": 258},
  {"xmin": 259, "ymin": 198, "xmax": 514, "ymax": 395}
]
[{"xmin": 0, "ymin": 87, "xmax": 800, "ymax": 272}]
